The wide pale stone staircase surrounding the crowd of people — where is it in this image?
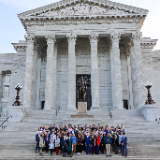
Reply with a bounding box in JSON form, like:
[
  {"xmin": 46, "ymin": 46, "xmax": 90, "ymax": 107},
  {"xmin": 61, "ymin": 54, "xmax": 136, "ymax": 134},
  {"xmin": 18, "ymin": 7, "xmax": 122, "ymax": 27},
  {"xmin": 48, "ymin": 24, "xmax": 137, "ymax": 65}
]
[{"xmin": 0, "ymin": 110, "xmax": 160, "ymax": 159}]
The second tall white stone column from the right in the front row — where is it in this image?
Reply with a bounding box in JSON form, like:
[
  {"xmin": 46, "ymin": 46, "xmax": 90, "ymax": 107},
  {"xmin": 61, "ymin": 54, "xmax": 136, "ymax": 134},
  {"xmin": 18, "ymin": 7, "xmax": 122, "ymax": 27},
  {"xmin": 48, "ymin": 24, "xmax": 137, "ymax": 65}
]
[{"xmin": 110, "ymin": 32, "xmax": 123, "ymax": 109}]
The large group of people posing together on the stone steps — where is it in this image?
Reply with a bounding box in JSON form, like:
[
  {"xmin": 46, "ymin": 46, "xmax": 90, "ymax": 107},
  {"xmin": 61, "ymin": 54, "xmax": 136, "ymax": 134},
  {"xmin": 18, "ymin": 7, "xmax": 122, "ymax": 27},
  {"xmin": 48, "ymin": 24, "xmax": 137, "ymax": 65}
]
[{"xmin": 35, "ymin": 124, "xmax": 127, "ymax": 157}]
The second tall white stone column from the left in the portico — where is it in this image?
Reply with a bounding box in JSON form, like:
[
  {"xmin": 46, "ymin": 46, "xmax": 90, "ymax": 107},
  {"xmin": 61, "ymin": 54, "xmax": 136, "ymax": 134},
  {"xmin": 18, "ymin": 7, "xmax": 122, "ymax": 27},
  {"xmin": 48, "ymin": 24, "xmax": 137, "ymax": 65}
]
[{"xmin": 44, "ymin": 35, "xmax": 56, "ymax": 110}]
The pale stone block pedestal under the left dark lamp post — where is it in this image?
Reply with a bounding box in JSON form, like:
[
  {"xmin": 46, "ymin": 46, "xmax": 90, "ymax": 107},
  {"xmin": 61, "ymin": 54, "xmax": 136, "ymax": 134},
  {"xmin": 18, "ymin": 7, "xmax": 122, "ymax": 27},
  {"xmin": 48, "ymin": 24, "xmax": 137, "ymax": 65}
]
[{"xmin": 8, "ymin": 106, "xmax": 25, "ymax": 122}]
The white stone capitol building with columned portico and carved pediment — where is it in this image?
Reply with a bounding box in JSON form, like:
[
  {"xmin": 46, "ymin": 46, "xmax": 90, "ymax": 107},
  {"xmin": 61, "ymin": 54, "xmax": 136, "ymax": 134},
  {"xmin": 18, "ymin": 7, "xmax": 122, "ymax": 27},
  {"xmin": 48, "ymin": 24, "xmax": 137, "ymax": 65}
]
[{"xmin": 0, "ymin": 0, "xmax": 160, "ymax": 117}]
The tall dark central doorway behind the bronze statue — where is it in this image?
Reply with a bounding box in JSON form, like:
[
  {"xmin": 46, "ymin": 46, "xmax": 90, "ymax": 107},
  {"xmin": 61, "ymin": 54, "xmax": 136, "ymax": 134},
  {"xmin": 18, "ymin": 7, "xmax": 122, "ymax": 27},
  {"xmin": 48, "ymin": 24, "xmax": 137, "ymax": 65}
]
[{"xmin": 76, "ymin": 74, "xmax": 92, "ymax": 110}]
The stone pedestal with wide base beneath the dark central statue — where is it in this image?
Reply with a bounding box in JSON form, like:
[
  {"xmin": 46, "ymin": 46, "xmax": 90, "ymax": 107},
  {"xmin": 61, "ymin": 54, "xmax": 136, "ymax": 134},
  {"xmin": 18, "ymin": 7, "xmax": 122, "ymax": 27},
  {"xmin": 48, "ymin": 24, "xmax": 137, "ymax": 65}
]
[{"xmin": 71, "ymin": 102, "xmax": 94, "ymax": 118}]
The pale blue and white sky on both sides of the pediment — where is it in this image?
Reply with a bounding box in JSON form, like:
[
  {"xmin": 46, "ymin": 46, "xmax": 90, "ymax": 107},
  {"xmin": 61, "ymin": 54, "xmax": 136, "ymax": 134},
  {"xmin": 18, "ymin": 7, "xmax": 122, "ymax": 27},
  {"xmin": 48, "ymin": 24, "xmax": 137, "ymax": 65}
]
[{"xmin": 0, "ymin": 0, "xmax": 160, "ymax": 53}]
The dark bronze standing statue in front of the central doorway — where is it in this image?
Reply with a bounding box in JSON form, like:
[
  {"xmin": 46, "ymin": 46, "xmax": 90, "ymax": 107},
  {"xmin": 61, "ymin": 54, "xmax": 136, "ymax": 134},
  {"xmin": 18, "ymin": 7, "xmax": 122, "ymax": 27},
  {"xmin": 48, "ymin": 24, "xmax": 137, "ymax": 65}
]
[{"xmin": 78, "ymin": 76, "xmax": 87, "ymax": 101}]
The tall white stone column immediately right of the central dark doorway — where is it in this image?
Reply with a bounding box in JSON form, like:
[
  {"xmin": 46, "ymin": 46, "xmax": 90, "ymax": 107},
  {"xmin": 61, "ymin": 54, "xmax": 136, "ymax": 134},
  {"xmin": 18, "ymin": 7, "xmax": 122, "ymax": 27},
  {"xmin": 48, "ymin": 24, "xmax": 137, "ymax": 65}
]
[{"xmin": 89, "ymin": 34, "xmax": 100, "ymax": 109}]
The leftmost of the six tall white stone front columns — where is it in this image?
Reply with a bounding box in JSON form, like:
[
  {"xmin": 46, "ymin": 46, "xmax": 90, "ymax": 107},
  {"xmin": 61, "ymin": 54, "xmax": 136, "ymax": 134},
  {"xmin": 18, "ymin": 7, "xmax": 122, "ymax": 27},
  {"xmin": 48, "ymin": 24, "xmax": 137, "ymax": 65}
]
[{"xmin": 23, "ymin": 34, "xmax": 35, "ymax": 109}]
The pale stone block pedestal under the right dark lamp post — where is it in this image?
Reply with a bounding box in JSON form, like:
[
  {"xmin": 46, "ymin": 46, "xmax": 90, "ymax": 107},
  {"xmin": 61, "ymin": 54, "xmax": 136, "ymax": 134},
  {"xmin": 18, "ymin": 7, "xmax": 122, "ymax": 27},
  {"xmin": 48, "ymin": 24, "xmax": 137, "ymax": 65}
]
[{"xmin": 141, "ymin": 104, "xmax": 159, "ymax": 121}]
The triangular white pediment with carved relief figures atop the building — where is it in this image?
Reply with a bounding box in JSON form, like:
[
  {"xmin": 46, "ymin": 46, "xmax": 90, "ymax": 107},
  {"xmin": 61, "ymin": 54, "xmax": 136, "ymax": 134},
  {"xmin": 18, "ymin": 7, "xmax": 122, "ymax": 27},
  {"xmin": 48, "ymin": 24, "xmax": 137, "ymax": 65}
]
[{"xmin": 19, "ymin": 0, "xmax": 148, "ymax": 18}]
